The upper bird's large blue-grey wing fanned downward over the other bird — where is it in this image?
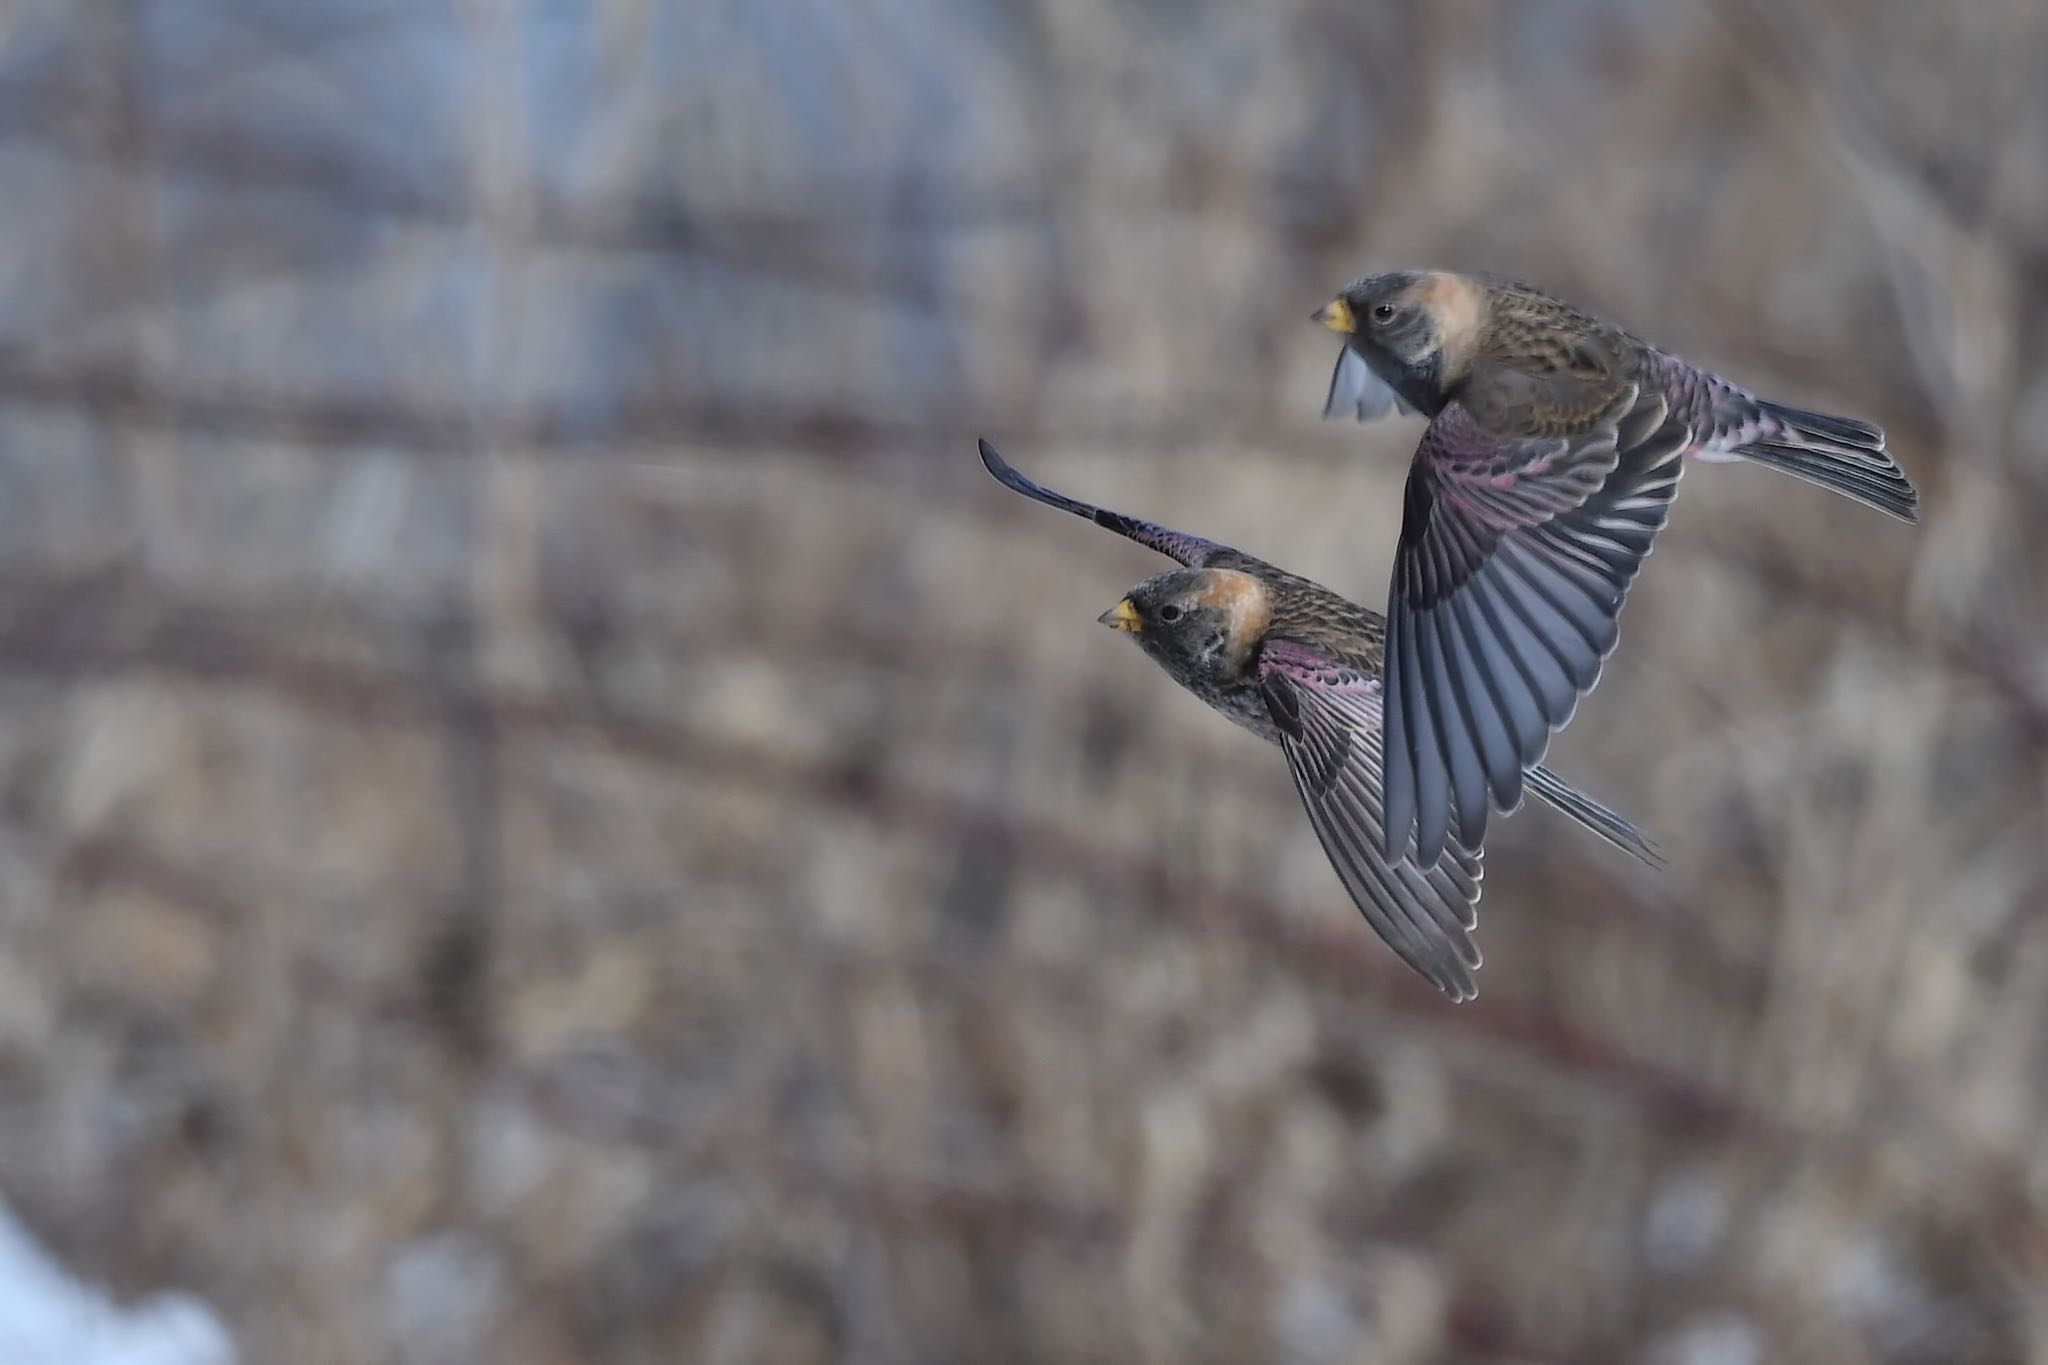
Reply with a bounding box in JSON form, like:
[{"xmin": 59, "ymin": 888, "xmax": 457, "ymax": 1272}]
[{"xmin": 1384, "ymin": 387, "xmax": 1692, "ymax": 868}]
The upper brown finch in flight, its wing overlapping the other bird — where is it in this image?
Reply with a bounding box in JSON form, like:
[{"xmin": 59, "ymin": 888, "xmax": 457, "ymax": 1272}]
[{"xmin": 1315, "ymin": 270, "xmax": 1919, "ymax": 868}]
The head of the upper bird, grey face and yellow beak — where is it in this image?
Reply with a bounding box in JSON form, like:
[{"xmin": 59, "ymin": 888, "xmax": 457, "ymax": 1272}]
[{"xmin": 1313, "ymin": 270, "xmax": 1487, "ymax": 417}]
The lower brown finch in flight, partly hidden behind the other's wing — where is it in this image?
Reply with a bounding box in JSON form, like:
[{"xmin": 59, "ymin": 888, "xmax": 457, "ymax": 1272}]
[{"xmin": 981, "ymin": 442, "xmax": 1659, "ymax": 1001}]
